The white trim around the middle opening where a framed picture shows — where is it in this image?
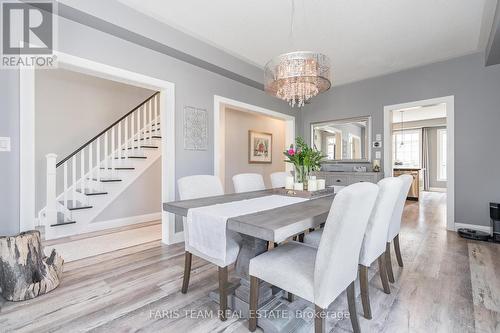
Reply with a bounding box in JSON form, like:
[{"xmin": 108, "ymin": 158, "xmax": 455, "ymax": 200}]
[{"xmin": 214, "ymin": 95, "xmax": 295, "ymax": 183}]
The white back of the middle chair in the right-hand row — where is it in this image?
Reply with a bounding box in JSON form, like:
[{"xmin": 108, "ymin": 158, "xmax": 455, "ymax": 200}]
[{"xmin": 359, "ymin": 177, "xmax": 403, "ymax": 267}]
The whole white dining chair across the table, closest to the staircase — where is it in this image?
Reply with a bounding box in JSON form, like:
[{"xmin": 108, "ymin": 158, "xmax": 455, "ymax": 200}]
[{"xmin": 177, "ymin": 175, "xmax": 240, "ymax": 320}]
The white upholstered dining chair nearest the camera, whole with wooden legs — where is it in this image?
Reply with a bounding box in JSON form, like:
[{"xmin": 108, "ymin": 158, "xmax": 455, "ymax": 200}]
[{"xmin": 249, "ymin": 183, "xmax": 378, "ymax": 332}]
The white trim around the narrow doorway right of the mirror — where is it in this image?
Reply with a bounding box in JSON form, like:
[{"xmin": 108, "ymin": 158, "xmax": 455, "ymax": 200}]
[{"xmin": 384, "ymin": 96, "xmax": 455, "ymax": 231}]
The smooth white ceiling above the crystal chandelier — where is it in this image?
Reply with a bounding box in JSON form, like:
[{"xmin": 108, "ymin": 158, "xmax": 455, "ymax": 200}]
[{"xmin": 119, "ymin": 0, "xmax": 497, "ymax": 85}]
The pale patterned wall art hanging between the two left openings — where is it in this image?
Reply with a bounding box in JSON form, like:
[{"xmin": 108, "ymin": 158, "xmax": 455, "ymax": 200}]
[{"xmin": 184, "ymin": 106, "xmax": 208, "ymax": 150}]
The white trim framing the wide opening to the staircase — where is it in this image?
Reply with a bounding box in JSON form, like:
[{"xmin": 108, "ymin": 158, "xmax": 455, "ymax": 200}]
[{"xmin": 19, "ymin": 51, "xmax": 175, "ymax": 244}]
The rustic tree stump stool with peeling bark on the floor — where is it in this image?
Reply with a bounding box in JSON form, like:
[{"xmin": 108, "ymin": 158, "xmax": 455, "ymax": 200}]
[{"xmin": 0, "ymin": 230, "xmax": 64, "ymax": 301}]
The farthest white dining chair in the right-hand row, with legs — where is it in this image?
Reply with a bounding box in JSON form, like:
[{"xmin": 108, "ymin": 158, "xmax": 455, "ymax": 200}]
[{"xmin": 385, "ymin": 175, "xmax": 413, "ymax": 283}]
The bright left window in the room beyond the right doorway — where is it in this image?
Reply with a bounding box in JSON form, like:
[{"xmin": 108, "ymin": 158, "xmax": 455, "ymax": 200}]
[{"xmin": 392, "ymin": 130, "xmax": 421, "ymax": 168}]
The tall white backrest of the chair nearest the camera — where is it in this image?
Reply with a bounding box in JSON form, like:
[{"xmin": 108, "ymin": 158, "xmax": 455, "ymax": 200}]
[{"xmin": 314, "ymin": 182, "xmax": 378, "ymax": 309}]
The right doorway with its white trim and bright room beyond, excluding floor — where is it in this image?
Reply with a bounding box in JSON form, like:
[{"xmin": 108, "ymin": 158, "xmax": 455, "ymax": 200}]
[{"xmin": 384, "ymin": 96, "xmax": 455, "ymax": 231}]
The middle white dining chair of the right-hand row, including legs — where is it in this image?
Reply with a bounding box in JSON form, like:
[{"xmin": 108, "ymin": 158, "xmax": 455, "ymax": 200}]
[{"xmin": 359, "ymin": 177, "xmax": 403, "ymax": 319}]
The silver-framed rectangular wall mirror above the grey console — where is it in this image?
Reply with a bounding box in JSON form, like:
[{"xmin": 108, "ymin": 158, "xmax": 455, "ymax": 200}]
[{"xmin": 311, "ymin": 116, "xmax": 371, "ymax": 163}]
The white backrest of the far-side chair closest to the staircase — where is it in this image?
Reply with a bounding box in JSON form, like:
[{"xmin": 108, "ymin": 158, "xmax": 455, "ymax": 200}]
[{"xmin": 177, "ymin": 175, "xmax": 224, "ymax": 200}]
